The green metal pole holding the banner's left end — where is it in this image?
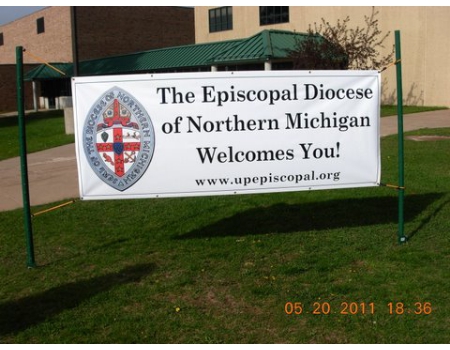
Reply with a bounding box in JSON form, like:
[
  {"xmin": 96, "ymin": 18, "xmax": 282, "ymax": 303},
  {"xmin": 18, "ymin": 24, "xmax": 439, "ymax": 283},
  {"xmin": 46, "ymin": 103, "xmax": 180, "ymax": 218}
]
[{"xmin": 16, "ymin": 46, "xmax": 36, "ymax": 268}]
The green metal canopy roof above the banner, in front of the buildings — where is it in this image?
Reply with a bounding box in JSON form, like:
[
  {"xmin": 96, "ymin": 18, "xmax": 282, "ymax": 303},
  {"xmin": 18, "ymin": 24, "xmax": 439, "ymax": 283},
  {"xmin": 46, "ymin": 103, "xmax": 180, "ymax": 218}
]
[{"xmin": 25, "ymin": 30, "xmax": 320, "ymax": 80}]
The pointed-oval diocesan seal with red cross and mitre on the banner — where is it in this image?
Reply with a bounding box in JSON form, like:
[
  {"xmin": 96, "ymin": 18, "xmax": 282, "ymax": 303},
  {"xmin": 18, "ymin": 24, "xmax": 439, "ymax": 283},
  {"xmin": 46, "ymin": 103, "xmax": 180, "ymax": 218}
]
[{"xmin": 83, "ymin": 87, "xmax": 155, "ymax": 191}]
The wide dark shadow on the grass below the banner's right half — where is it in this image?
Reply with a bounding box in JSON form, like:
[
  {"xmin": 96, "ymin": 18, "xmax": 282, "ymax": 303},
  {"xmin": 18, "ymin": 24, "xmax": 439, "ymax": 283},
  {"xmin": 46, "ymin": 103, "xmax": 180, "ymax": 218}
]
[{"xmin": 176, "ymin": 193, "xmax": 444, "ymax": 239}]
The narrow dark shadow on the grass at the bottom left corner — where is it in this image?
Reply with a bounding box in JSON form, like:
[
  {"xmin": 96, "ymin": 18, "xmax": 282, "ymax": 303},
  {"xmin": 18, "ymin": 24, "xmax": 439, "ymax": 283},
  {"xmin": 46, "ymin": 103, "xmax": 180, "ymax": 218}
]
[{"xmin": 0, "ymin": 264, "xmax": 155, "ymax": 339}]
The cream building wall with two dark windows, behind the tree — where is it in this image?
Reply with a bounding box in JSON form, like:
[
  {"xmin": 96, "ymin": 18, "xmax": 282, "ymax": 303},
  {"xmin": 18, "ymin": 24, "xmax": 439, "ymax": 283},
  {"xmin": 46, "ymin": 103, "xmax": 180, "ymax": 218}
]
[{"xmin": 195, "ymin": 6, "xmax": 450, "ymax": 106}]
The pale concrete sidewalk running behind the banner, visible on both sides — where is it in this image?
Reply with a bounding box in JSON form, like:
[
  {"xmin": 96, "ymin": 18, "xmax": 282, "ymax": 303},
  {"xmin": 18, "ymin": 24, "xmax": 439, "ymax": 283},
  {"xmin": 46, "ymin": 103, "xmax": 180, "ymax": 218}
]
[{"xmin": 0, "ymin": 110, "xmax": 450, "ymax": 211}]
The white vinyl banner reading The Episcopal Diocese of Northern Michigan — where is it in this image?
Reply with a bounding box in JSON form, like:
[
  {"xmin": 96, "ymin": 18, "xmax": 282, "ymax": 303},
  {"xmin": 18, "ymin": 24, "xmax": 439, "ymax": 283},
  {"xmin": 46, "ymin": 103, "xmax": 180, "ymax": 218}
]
[{"xmin": 72, "ymin": 71, "xmax": 380, "ymax": 199}]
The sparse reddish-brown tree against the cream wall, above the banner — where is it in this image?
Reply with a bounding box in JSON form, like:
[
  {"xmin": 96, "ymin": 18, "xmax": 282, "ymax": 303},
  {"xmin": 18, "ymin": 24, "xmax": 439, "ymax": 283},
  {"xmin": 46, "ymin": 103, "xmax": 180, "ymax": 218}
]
[{"xmin": 291, "ymin": 7, "xmax": 394, "ymax": 70}]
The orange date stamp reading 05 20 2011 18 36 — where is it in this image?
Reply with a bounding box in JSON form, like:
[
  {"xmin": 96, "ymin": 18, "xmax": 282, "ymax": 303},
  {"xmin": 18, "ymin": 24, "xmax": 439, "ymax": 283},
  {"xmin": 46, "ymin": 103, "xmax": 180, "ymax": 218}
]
[{"xmin": 284, "ymin": 301, "xmax": 433, "ymax": 315}]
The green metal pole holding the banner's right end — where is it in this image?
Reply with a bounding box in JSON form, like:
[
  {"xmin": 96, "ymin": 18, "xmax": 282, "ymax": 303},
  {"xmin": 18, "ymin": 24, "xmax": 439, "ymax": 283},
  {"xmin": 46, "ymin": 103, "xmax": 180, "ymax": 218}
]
[{"xmin": 395, "ymin": 30, "xmax": 406, "ymax": 244}]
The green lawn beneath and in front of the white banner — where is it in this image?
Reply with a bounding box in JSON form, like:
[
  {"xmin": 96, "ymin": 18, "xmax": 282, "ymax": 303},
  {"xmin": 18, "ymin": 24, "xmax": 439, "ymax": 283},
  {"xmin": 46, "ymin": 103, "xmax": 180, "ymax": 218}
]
[{"xmin": 0, "ymin": 124, "xmax": 450, "ymax": 343}]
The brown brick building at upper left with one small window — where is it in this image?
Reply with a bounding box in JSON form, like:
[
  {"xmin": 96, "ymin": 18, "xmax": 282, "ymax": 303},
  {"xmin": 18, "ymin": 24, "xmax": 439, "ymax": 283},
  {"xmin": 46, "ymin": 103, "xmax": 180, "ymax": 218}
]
[{"xmin": 0, "ymin": 6, "xmax": 195, "ymax": 112}]
